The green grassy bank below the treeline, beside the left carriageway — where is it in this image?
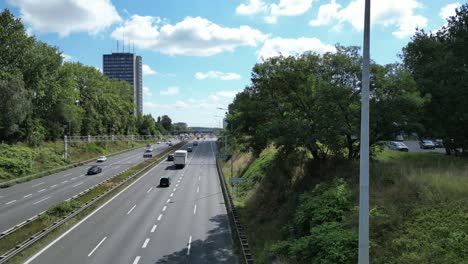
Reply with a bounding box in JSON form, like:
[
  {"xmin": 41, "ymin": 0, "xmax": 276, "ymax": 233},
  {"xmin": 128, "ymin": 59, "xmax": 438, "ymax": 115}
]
[{"xmin": 0, "ymin": 139, "xmax": 157, "ymax": 185}]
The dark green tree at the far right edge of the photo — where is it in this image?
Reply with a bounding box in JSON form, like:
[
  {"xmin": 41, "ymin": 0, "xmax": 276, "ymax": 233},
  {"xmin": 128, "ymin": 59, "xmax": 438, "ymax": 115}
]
[{"xmin": 403, "ymin": 4, "xmax": 468, "ymax": 154}]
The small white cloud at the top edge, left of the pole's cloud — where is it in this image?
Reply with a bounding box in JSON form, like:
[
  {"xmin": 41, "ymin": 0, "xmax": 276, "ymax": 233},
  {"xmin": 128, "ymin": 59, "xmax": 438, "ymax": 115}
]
[{"xmin": 236, "ymin": 0, "xmax": 314, "ymax": 24}]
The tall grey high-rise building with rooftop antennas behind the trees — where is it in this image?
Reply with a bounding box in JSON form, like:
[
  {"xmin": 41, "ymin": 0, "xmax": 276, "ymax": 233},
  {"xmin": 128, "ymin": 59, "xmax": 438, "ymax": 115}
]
[{"xmin": 102, "ymin": 52, "xmax": 143, "ymax": 114}]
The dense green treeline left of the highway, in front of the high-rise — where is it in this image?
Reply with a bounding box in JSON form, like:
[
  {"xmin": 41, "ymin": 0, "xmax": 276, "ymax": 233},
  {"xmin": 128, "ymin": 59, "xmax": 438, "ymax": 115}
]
[{"xmin": 0, "ymin": 9, "xmax": 172, "ymax": 145}]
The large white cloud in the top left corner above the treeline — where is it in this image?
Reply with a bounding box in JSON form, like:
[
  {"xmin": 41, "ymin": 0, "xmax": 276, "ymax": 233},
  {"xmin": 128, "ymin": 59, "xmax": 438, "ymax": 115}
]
[{"xmin": 8, "ymin": 0, "xmax": 121, "ymax": 37}]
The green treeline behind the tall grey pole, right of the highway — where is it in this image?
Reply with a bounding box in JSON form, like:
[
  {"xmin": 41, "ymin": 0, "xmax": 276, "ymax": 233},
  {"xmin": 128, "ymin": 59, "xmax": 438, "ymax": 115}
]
[{"xmin": 228, "ymin": 4, "xmax": 468, "ymax": 160}]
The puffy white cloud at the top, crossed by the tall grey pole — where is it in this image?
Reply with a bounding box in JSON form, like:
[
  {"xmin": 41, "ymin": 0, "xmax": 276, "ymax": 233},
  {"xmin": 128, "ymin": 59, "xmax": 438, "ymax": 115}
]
[{"xmin": 309, "ymin": 0, "xmax": 428, "ymax": 38}]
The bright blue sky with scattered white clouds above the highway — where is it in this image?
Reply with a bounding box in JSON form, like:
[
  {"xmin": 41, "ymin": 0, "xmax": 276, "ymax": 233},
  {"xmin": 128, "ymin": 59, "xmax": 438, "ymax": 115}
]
[{"xmin": 0, "ymin": 0, "xmax": 464, "ymax": 126}]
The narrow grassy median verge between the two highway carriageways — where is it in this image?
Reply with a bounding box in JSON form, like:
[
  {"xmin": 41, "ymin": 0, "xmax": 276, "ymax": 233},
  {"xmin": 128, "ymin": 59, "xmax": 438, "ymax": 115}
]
[{"xmin": 0, "ymin": 142, "xmax": 184, "ymax": 263}]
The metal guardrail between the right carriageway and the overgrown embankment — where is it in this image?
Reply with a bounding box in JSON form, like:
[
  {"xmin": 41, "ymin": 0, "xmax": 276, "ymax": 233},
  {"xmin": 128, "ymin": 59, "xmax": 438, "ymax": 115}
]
[{"xmin": 216, "ymin": 158, "xmax": 254, "ymax": 264}]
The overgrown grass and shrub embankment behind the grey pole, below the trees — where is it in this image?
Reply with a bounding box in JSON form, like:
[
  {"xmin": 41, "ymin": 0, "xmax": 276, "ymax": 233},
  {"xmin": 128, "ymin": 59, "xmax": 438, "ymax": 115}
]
[{"xmin": 223, "ymin": 148, "xmax": 468, "ymax": 263}]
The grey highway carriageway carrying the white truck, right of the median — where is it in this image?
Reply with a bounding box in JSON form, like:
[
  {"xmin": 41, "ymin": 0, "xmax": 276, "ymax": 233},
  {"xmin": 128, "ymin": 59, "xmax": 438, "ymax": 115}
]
[{"xmin": 25, "ymin": 141, "xmax": 238, "ymax": 264}]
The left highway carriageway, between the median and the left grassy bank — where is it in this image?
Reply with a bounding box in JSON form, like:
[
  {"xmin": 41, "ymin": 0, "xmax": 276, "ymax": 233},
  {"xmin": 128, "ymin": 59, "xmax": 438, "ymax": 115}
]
[{"xmin": 0, "ymin": 143, "xmax": 179, "ymax": 231}]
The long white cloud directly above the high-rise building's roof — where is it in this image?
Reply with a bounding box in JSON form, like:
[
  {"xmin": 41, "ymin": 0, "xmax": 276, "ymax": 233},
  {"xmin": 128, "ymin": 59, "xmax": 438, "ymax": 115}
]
[{"xmin": 112, "ymin": 15, "xmax": 267, "ymax": 56}]
